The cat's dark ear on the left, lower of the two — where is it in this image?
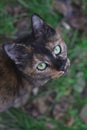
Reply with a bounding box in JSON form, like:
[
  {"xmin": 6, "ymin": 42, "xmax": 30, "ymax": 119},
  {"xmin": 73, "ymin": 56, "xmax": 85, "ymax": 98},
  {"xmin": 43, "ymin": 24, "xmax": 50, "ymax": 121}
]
[{"xmin": 3, "ymin": 43, "xmax": 28, "ymax": 66}]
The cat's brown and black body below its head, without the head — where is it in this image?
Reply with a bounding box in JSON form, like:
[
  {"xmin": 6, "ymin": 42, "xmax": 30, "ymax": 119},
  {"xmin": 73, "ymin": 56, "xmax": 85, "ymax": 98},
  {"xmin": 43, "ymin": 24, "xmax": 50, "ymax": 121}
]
[{"xmin": 0, "ymin": 46, "xmax": 31, "ymax": 112}]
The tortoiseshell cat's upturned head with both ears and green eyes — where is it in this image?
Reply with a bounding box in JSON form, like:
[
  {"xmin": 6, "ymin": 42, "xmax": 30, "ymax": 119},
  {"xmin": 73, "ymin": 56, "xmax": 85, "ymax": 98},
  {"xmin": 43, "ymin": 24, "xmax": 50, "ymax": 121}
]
[{"xmin": 4, "ymin": 14, "xmax": 70, "ymax": 86}]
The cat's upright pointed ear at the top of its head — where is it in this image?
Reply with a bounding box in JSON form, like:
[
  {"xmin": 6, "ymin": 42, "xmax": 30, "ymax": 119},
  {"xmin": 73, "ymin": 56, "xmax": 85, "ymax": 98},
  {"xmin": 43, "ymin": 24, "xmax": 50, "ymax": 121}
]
[{"xmin": 31, "ymin": 14, "xmax": 56, "ymax": 38}]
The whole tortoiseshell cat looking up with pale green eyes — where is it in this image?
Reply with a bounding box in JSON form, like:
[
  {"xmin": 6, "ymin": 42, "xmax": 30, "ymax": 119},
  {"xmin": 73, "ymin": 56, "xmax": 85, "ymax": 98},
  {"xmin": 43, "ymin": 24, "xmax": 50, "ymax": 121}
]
[{"xmin": 0, "ymin": 14, "xmax": 70, "ymax": 112}]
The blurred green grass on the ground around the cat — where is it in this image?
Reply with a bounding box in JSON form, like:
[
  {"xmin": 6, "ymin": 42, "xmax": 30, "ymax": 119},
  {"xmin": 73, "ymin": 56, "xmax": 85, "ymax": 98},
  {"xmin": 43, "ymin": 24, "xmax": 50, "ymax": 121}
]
[{"xmin": 0, "ymin": 0, "xmax": 87, "ymax": 130}]
